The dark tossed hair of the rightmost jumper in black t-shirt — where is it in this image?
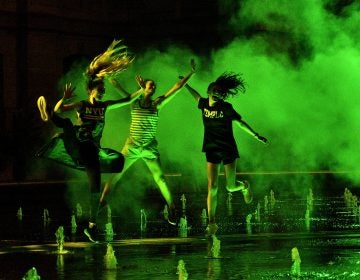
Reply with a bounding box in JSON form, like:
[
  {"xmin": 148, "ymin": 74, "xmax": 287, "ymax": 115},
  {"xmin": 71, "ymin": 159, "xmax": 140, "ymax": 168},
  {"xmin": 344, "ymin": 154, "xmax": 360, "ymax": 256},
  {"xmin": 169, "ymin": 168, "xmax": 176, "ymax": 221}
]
[{"xmin": 207, "ymin": 72, "xmax": 246, "ymax": 99}]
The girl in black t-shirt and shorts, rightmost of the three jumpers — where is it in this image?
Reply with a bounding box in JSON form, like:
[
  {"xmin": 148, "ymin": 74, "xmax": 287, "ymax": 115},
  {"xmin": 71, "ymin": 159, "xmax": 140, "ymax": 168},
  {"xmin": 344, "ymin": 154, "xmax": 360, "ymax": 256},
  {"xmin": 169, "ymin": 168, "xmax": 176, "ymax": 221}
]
[{"xmin": 185, "ymin": 73, "xmax": 267, "ymax": 237}]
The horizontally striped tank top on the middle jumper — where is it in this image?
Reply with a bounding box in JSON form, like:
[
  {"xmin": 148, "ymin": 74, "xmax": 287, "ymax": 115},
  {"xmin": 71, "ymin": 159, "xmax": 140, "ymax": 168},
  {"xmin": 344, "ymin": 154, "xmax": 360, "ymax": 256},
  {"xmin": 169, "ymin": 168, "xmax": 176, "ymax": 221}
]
[{"xmin": 130, "ymin": 100, "xmax": 159, "ymax": 144}]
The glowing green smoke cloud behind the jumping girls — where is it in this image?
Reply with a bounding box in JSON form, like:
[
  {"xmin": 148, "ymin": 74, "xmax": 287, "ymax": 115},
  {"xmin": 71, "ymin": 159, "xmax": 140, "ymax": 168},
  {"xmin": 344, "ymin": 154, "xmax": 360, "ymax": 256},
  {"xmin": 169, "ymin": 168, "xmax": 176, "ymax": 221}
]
[{"xmin": 50, "ymin": 0, "xmax": 360, "ymax": 211}]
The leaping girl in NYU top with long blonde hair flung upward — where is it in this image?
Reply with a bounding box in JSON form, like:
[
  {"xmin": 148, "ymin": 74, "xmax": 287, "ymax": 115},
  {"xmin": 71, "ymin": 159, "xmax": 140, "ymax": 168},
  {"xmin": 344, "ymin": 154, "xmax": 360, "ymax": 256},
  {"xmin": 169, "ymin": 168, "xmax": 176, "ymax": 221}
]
[{"xmin": 37, "ymin": 40, "xmax": 140, "ymax": 241}]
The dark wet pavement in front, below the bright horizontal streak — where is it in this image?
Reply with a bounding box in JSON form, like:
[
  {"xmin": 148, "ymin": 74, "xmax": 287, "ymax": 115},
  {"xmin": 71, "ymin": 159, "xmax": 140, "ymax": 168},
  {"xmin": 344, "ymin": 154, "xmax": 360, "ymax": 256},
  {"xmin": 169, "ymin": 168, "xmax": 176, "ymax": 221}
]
[{"xmin": 0, "ymin": 232, "xmax": 360, "ymax": 279}]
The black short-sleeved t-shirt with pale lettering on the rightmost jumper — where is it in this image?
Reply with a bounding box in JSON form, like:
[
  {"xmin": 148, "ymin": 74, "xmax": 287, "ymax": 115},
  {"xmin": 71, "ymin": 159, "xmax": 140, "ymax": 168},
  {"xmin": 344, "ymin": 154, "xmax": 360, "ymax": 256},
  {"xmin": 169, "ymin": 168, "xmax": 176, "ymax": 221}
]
[{"xmin": 198, "ymin": 98, "xmax": 241, "ymax": 153}]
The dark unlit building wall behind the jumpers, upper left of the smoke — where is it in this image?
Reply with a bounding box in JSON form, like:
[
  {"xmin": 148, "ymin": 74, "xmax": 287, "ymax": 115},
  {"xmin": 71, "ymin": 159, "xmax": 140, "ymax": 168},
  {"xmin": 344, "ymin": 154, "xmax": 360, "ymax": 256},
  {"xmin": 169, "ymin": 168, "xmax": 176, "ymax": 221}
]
[{"xmin": 0, "ymin": 0, "xmax": 221, "ymax": 182}]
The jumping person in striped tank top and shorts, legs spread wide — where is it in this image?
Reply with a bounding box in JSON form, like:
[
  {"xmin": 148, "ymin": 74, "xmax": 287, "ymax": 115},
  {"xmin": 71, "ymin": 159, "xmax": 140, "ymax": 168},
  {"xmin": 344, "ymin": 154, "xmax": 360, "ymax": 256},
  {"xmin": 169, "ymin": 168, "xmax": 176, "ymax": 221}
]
[{"xmin": 100, "ymin": 60, "xmax": 195, "ymax": 225}]
